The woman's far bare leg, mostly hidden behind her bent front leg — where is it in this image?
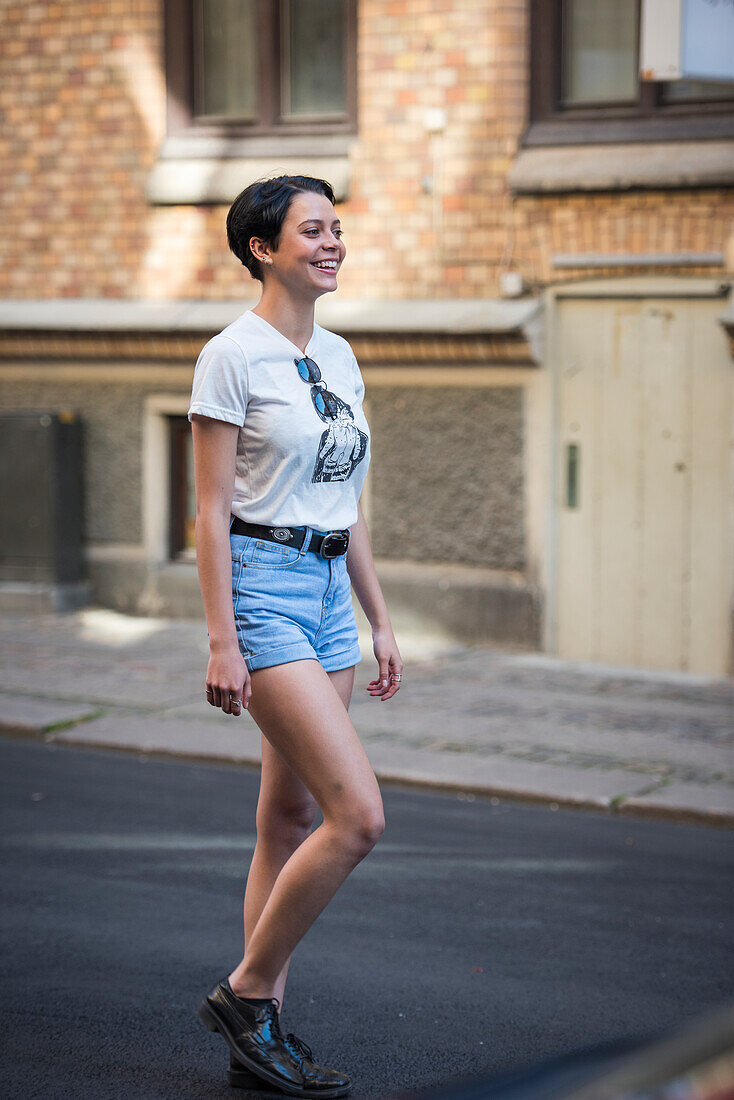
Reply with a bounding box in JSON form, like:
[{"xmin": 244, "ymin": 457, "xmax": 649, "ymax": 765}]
[{"xmin": 232, "ymin": 668, "xmax": 354, "ymax": 1010}]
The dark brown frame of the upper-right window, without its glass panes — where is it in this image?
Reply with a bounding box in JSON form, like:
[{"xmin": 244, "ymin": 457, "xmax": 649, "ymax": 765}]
[{"xmin": 522, "ymin": 0, "xmax": 734, "ymax": 145}]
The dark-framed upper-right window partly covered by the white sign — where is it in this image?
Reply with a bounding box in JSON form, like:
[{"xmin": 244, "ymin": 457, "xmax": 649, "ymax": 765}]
[{"xmin": 524, "ymin": 0, "xmax": 734, "ymax": 145}]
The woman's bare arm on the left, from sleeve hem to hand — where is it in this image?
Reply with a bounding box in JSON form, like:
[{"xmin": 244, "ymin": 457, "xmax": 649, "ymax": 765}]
[{"xmin": 191, "ymin": 413, "xmax": 252, "ymax": 714}]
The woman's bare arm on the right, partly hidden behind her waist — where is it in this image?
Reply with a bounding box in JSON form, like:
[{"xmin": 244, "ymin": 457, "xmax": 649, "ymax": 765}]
[{"xmin": 347, "ymin": 504, "xmax": 403, "ymax": 702}]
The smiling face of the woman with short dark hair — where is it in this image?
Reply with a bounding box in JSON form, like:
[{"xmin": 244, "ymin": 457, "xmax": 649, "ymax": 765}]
[{"xmin": 264, "ymin": 191, "xmax": 347, "ymax": 298}]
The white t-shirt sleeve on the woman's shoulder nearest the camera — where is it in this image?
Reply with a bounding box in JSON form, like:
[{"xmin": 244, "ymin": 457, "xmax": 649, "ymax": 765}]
[{"xmin": 187, "ymin": 333, "xmax": 249, "ymax": 427}]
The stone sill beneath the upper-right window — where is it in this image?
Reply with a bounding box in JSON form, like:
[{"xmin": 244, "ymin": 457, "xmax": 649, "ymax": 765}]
[{"xmin": 507, "ymin": 141, "xmax": 734, "ymax": 195}]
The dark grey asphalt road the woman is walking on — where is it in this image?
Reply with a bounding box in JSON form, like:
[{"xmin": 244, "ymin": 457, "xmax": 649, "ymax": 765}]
[{"xmin": 0, "ymin": 739, "xmax": 734, "ymax": 1100}]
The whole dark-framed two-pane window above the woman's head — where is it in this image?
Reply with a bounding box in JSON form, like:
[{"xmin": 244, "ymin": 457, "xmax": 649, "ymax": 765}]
[{"xmin": 165, "ymin": 0, "xmax": 357, "ymax": 138}]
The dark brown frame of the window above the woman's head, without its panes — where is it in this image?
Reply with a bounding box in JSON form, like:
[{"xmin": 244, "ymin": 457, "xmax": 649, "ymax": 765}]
[{"xmin": 164, "ymin": 0, "xmax": 357, "ymax": 139}]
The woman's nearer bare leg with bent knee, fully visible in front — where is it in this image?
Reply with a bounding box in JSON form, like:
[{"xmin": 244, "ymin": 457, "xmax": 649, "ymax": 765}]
[{"xmin": 230, "ymin": 660, "xmax": 384, "ymax": 997}]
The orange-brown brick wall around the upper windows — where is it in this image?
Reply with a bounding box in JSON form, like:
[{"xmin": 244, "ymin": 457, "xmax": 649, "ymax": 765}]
[{"xmin": 0, "ymin": 0, "xmax": 734, "ymax": 298}]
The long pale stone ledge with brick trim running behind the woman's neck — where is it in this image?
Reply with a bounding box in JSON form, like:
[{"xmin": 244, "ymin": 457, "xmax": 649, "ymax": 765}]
[{"xmin": 0, "ymin": 298, "xmax": 543, "ymax": 366}]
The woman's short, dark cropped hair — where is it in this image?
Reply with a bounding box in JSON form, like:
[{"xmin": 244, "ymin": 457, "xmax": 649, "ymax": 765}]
[{"xmin": 227, "ymin": 176, "xmax": 336, "ymax": 283}]
